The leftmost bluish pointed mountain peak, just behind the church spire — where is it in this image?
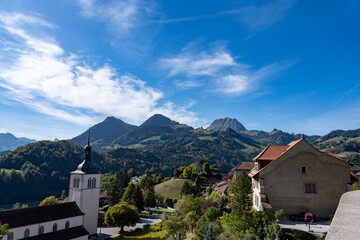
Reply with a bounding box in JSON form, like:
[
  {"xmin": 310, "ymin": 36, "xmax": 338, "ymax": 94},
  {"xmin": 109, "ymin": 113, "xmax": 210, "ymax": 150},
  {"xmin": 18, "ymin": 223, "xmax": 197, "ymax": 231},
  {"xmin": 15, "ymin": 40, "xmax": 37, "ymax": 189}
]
[{"xmin": 69, "ymin": 117, "xmax": 136, "ymax": 149}]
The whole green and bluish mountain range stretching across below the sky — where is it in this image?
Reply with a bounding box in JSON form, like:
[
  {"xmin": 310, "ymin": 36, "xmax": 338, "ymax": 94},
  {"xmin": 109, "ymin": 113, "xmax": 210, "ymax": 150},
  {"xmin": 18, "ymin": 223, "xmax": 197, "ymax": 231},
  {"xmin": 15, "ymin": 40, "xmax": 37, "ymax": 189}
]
[{"xmin": 0, "ymin": 114, "xmax": 360, "ymax": 205}]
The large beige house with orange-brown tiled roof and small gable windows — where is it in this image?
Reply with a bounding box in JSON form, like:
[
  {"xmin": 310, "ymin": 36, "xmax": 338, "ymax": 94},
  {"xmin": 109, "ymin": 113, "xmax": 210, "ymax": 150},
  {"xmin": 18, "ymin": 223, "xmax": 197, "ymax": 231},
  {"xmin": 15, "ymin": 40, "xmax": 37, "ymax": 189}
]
[{"xmin": 249, "ymin": 137, "xmax": 351, "ymax": 218}]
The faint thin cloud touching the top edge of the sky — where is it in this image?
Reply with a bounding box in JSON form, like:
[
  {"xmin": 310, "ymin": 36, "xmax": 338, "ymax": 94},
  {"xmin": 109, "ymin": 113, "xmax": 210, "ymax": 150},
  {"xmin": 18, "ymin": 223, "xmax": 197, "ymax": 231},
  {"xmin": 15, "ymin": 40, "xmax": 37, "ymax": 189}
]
[{"xmin": 78, "ymin": 0, "xmax": 157, "ymax": 57}]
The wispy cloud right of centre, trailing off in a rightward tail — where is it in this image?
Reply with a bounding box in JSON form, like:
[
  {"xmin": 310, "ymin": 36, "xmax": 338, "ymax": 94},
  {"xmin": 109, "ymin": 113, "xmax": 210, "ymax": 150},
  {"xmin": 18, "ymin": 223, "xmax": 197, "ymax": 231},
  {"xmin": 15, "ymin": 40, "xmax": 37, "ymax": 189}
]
[{"xmin": 159, "ymin": 42, "xmax": 294, "ymax": 96}]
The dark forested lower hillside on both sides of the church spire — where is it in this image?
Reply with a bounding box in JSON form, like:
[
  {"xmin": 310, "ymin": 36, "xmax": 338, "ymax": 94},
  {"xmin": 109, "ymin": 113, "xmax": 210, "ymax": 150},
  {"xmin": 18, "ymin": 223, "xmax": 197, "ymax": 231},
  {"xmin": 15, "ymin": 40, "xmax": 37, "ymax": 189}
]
[{"xmin": 0, "ymin": 128, "xmax": 261, "ymax": 205}]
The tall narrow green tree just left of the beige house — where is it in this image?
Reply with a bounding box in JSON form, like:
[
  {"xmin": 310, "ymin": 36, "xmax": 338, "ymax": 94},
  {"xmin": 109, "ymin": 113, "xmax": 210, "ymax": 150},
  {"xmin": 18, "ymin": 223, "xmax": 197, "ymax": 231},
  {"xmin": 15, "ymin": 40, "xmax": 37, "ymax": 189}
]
[{"xmin": 230, "ymin": 172, "xmax": 251, "ymax": 217}]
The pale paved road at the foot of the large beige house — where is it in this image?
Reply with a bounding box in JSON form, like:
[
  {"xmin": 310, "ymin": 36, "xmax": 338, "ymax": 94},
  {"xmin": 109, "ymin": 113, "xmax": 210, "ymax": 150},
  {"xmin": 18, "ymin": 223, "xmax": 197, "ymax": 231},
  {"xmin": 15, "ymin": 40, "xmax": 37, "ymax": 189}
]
[{"xmin": 278, "ymin": 220, "xmax": 330, "ymax": 239}]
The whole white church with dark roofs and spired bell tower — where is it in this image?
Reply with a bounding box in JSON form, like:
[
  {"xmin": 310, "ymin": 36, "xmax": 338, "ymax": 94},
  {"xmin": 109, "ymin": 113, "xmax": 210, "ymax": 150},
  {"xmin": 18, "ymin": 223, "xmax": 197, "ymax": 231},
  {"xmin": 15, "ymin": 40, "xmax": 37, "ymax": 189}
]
[{"xmin": 0, "ymin": 139, "xmax": 101, "ymax": 240}]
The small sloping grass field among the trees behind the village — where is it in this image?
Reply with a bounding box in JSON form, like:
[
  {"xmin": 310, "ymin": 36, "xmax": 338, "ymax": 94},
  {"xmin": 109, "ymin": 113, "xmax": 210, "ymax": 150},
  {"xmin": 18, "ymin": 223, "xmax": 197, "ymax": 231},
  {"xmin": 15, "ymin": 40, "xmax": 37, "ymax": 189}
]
[{"xmin": 155, "ymin": 178, "xmax": 193, "ymax": 199}]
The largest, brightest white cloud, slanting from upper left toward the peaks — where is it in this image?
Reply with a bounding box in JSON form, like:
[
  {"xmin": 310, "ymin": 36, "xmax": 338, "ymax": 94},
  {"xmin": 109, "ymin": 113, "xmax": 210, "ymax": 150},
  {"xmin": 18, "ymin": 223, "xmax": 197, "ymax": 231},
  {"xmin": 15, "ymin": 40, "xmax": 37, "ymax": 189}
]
[{"xmin": 0, "ymin": 13, "xmax": 198, "ymax": 125}]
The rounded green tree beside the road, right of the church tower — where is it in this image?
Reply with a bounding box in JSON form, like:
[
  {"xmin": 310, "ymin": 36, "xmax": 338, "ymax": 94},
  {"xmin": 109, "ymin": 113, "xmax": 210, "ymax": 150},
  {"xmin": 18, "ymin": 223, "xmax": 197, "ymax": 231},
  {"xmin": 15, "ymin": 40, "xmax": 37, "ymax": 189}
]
[{"xmin": 105, "ymin": 202, "xmax": 140, "ymax": 232}]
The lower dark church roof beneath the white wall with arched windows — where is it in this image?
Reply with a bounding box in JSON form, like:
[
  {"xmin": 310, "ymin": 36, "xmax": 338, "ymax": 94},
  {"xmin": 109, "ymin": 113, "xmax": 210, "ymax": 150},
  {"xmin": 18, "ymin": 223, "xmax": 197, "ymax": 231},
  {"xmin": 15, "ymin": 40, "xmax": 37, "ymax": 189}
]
[{"xmin": 18, "ymin": 226, "xmax": 89, "ymax": 240}]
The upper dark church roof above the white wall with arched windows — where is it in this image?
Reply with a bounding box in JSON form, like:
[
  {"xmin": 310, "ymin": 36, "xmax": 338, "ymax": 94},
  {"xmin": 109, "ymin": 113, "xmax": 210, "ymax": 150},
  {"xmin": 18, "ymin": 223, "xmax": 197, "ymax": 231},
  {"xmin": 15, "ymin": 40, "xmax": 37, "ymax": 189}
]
[{"xmin": 0, "ymin": 202, "xmax": 84, "ymax": 228}]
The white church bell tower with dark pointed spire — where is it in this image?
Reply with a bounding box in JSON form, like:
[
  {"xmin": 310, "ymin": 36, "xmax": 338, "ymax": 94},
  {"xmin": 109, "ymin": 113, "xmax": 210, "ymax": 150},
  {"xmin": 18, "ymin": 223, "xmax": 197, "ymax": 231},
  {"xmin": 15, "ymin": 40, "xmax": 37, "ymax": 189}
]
[{"xmin": 69, "ymin": 129, "xmax": 101, "ymax": 235}]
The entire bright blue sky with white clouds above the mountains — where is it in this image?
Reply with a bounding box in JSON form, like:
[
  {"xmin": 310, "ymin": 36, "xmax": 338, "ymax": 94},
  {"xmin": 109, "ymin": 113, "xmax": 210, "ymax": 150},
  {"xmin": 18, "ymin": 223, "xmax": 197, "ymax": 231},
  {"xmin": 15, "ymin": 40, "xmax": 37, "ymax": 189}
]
[{"xmin": 0, "ymin": 0, "xmax": 360, "ymax": 139}]
